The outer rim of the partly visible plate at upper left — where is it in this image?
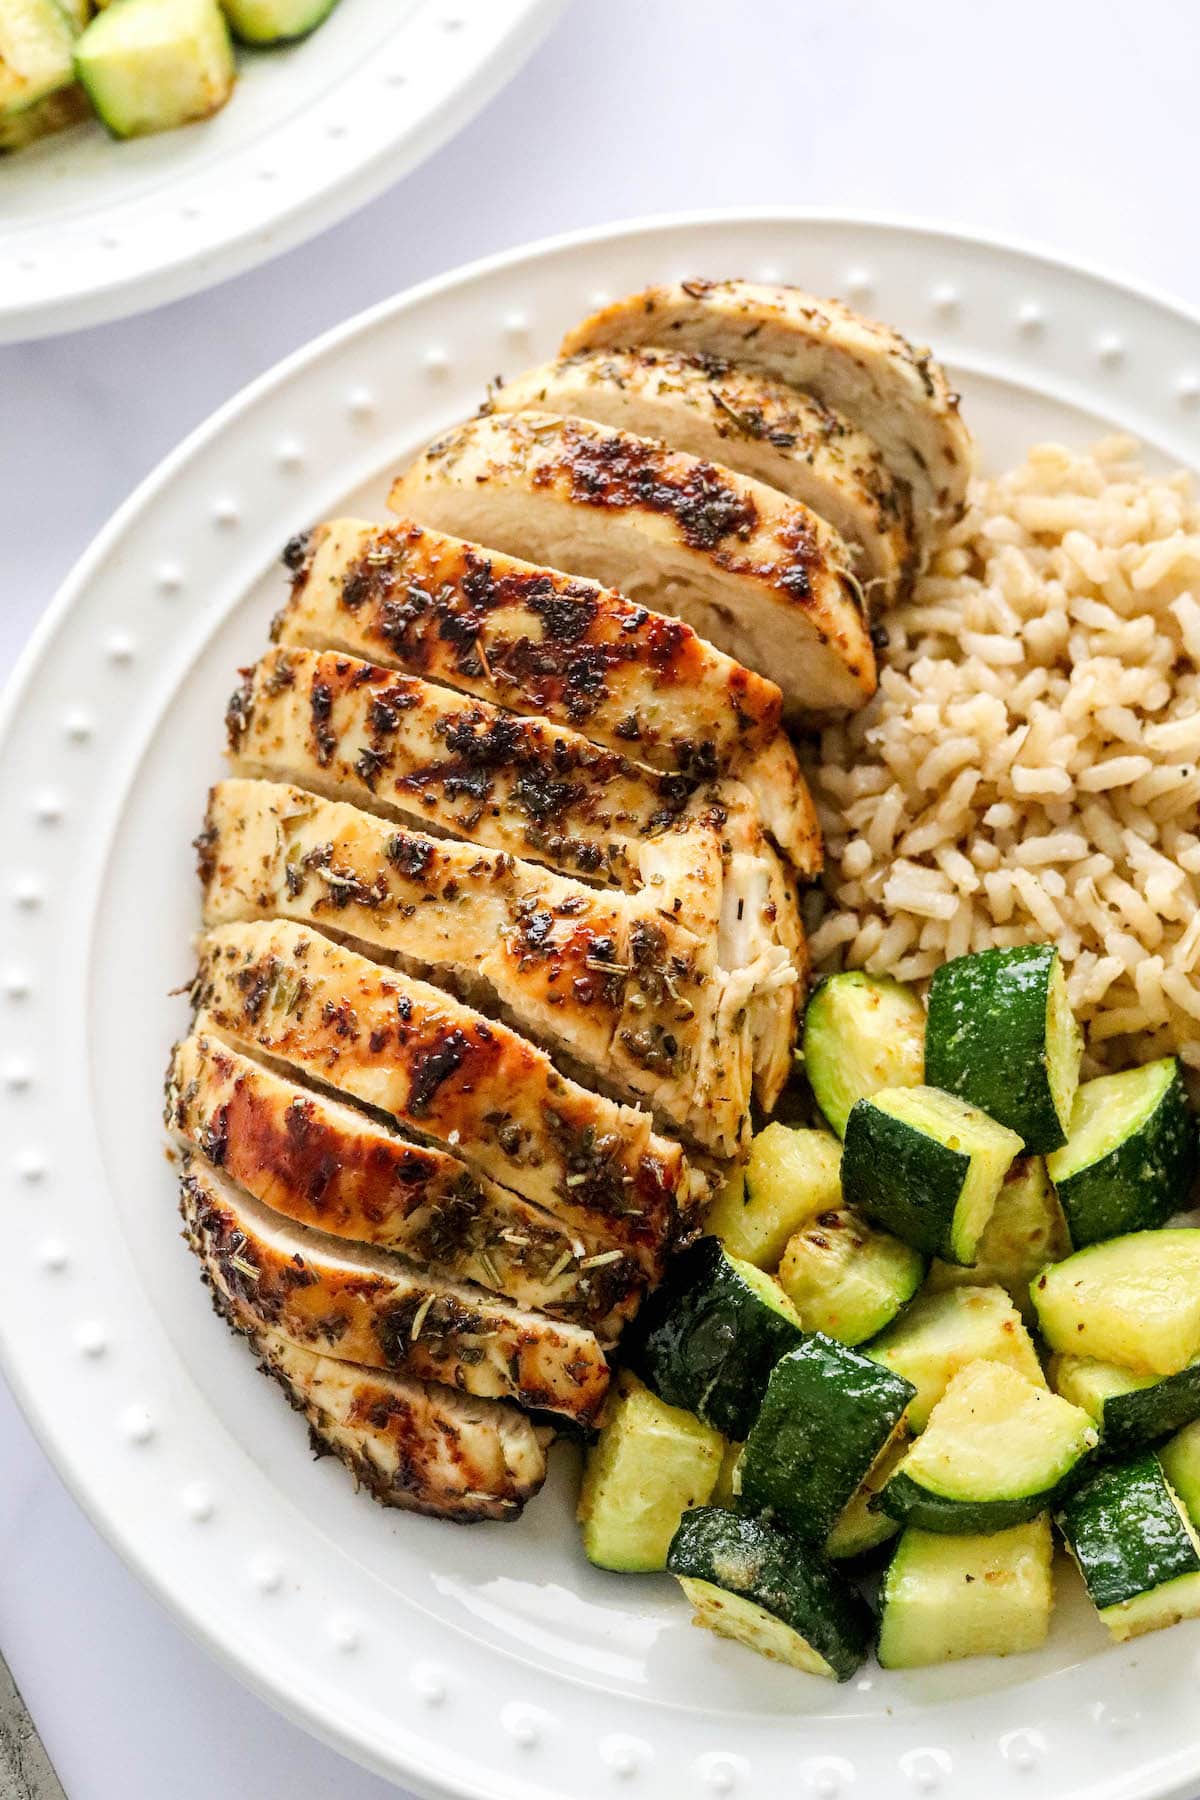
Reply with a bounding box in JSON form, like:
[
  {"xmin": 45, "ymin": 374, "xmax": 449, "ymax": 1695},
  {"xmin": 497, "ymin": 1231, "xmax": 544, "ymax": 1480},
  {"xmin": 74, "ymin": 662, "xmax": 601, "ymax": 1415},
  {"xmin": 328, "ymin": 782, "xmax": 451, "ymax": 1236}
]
[{"xmin": 0, "ymin": 0, "xmax": 569, "ymax": 346}]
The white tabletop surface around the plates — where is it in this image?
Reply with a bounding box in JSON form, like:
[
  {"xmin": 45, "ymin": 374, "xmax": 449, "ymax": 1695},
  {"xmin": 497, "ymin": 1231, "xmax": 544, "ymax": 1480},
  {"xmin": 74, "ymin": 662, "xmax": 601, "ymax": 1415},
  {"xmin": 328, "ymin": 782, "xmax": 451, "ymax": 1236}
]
[{"xmin": 0, "ymin": 0, "xmax": 1200, "ymax": 1800}]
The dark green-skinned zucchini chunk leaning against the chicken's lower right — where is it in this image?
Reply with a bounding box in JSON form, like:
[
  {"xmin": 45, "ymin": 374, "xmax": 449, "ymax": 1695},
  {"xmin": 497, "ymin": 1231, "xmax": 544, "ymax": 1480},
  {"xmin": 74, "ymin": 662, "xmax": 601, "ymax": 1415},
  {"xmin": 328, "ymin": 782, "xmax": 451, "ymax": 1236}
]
[{"xmin": 624, "ymin": 1237, "xmax": 804, "ymax": 1438}]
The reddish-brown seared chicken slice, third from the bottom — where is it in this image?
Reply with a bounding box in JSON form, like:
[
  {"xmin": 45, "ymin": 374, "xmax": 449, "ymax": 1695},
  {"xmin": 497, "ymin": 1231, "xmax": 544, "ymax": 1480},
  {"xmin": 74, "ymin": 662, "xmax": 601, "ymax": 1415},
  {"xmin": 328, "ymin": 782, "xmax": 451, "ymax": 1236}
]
[{"xmin": 166, "ymin": 1015, "xmax": 646, "ymax": 1343}]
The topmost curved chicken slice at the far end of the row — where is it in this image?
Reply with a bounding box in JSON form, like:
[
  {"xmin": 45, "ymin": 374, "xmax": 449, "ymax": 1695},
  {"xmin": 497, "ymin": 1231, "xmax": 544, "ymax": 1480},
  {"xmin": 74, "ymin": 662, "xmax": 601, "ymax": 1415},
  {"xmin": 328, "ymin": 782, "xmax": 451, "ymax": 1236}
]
[{"xmin": 560, "ymin": 281, "xmax": 972, "ymax": 549}]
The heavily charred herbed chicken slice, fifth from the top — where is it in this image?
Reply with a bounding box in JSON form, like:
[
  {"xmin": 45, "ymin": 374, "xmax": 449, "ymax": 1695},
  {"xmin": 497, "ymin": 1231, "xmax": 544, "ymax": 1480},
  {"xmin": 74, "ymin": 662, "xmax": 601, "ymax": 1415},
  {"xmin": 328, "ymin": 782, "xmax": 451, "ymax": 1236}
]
[{"xmin": 228, "ymin": 650, "xmax": 694, "ymax": 886}]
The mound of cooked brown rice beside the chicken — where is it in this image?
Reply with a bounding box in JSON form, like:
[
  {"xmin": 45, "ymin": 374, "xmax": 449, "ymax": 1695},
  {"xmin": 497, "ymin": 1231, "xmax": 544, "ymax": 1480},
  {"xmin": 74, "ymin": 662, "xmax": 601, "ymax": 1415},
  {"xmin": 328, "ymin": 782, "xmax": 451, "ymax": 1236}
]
[{"xmin": 806, "ymin": 437, "xmax": 1200, "ymax": 1069}]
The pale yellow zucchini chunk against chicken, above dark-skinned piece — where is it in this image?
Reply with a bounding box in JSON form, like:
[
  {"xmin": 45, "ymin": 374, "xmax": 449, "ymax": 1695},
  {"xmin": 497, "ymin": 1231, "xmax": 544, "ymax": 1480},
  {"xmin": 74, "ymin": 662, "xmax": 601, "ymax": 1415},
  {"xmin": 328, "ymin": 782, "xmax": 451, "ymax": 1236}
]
[{"xmin": 705, "ymin": 1123, "xmax": 842, "ymax": 1271}]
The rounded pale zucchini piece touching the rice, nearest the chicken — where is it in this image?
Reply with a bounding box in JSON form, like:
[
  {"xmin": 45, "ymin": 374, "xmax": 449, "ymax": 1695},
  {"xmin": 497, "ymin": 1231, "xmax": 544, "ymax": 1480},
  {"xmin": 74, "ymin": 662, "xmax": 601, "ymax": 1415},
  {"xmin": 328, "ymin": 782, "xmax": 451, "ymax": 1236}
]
[{"xmin": 804, "ymin": 968, "xmax": 925, "ymax": 1138}]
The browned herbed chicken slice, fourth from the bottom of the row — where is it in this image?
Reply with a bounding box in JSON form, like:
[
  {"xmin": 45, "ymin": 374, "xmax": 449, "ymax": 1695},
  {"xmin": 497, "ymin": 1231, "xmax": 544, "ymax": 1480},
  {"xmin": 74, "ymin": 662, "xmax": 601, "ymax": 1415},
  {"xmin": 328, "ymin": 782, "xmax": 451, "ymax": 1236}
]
[{"xmin": 194, "ymin": 920, "xmax": 690, "ymax": 1280}]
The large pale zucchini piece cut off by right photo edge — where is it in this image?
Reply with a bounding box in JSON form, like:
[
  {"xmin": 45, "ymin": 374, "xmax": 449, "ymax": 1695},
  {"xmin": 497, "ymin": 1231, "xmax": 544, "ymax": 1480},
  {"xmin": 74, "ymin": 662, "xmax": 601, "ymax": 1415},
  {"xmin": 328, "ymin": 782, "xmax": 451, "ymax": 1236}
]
[{"xmin": 1029, "ymin": 1229, "xmax": 1200, "ymax": 1375}]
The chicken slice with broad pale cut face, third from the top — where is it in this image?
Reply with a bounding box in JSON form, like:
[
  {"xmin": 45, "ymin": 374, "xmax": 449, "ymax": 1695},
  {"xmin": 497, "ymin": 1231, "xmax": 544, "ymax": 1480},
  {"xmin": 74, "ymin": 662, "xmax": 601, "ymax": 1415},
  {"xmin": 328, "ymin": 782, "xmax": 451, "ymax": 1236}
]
[{"xmin": 389, "ymin": 412, "xmax": 876, "ymax": 716}]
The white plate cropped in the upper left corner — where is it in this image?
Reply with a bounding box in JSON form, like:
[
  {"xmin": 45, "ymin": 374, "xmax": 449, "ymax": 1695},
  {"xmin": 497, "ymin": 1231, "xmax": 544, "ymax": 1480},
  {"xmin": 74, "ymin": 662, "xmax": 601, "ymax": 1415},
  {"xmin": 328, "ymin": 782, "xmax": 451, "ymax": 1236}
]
[{"xmin": 0, "ymin": 0, "xmax": 565, "ymax": 344}]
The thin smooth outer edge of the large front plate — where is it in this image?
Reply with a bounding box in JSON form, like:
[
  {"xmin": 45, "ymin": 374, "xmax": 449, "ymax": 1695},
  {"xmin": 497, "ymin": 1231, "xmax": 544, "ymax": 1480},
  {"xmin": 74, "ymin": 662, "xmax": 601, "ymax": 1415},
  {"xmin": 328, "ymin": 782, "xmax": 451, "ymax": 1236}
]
[{"xmin": 0, "ymin": 205, "xmax": 1200, "ymax": 1800}]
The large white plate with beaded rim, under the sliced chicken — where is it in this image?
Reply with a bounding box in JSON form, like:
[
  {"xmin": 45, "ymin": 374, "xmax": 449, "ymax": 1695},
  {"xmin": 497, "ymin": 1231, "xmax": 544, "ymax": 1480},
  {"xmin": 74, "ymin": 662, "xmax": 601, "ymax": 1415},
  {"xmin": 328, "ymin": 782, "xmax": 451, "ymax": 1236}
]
[{"xmin": 0, "ymin": 216, "xmax": 1200, "ymax": 1800}]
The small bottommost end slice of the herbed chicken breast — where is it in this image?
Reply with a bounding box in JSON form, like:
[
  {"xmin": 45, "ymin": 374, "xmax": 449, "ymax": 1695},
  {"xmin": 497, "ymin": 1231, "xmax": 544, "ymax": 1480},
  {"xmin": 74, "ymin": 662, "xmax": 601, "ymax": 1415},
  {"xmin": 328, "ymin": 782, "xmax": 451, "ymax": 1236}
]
[{"xmin": 224, "ymin": 1294, "xmax": 547, "ymax": 1525}]
